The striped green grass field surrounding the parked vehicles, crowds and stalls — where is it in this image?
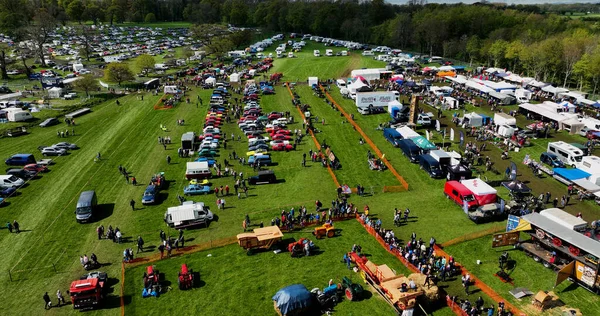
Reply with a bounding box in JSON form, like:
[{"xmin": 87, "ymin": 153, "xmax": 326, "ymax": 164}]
[{"xmin": 0, "ymin": 38, "xmax": 598, "ymax": 315}]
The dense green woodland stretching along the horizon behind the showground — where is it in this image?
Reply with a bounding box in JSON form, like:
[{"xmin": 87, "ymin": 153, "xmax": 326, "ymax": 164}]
[{"xmin": 0, "ymin": 0, "xmax": 600, "ymax": 92}]
